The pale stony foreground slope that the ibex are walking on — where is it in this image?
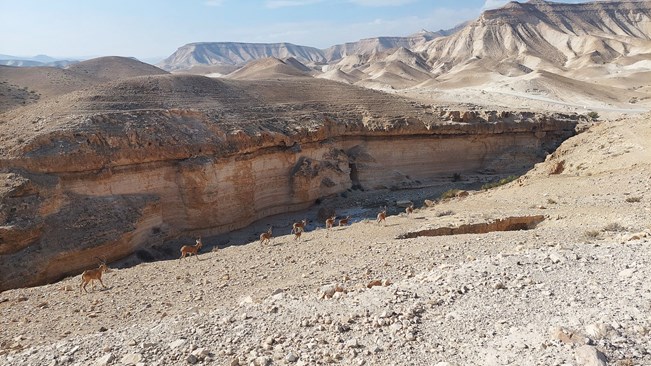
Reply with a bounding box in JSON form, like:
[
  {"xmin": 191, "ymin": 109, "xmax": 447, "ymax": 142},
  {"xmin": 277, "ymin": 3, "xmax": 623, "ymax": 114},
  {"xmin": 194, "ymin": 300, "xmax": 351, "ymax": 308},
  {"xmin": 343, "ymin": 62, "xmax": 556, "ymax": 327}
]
[{"xmin": 0, "ymin": 115, "xmax": 651, "ymax": 366}]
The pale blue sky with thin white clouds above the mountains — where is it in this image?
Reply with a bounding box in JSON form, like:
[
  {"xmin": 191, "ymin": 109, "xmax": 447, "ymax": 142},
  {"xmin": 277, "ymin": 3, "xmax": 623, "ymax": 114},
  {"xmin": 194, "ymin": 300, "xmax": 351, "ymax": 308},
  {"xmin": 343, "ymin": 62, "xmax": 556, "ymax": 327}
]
[{"xmin": 0, "ymin": 0, "xmax": 582, "ymax": 61}]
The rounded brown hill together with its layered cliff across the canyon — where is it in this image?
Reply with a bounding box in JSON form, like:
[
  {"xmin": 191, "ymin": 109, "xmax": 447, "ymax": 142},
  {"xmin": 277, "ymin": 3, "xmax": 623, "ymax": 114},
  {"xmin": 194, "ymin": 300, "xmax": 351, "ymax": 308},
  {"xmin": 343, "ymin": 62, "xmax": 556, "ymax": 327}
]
[{"xmin": 0, "ymin": 75, "xmax": 578, "ymax": 290}]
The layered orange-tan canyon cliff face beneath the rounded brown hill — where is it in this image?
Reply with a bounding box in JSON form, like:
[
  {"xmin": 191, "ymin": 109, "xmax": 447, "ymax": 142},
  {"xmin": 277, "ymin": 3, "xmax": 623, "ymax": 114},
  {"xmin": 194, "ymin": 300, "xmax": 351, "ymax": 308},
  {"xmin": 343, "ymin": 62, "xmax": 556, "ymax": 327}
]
[{"xmin": 0, "ymin": 112, "xmax": 578, "ymax": 291}]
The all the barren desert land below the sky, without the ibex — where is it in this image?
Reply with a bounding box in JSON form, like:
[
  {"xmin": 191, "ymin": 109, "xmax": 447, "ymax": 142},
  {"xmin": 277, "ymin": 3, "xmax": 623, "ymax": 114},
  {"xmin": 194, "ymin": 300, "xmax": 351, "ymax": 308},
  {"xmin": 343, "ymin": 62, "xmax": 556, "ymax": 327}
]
[{"xmin": 0, "ymin": 0, "xmax": 651, "ymax": 366}]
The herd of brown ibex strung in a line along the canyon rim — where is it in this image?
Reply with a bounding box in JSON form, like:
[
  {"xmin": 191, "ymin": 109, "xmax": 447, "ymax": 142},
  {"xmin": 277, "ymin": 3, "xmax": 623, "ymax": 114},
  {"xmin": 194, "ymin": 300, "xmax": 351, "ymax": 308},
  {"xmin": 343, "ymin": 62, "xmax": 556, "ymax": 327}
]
[{"xmin": 79, "ymin": 203, "xmax": 414, "ymax": 293}]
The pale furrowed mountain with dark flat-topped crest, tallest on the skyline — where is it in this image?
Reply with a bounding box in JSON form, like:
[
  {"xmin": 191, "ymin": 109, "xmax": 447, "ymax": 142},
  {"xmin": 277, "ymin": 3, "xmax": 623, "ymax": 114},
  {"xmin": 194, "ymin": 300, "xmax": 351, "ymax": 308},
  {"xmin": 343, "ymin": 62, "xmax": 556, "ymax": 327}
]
[{"xmin": 426, "ymin": 1, "xmax": 651, "ymax": 73}]
